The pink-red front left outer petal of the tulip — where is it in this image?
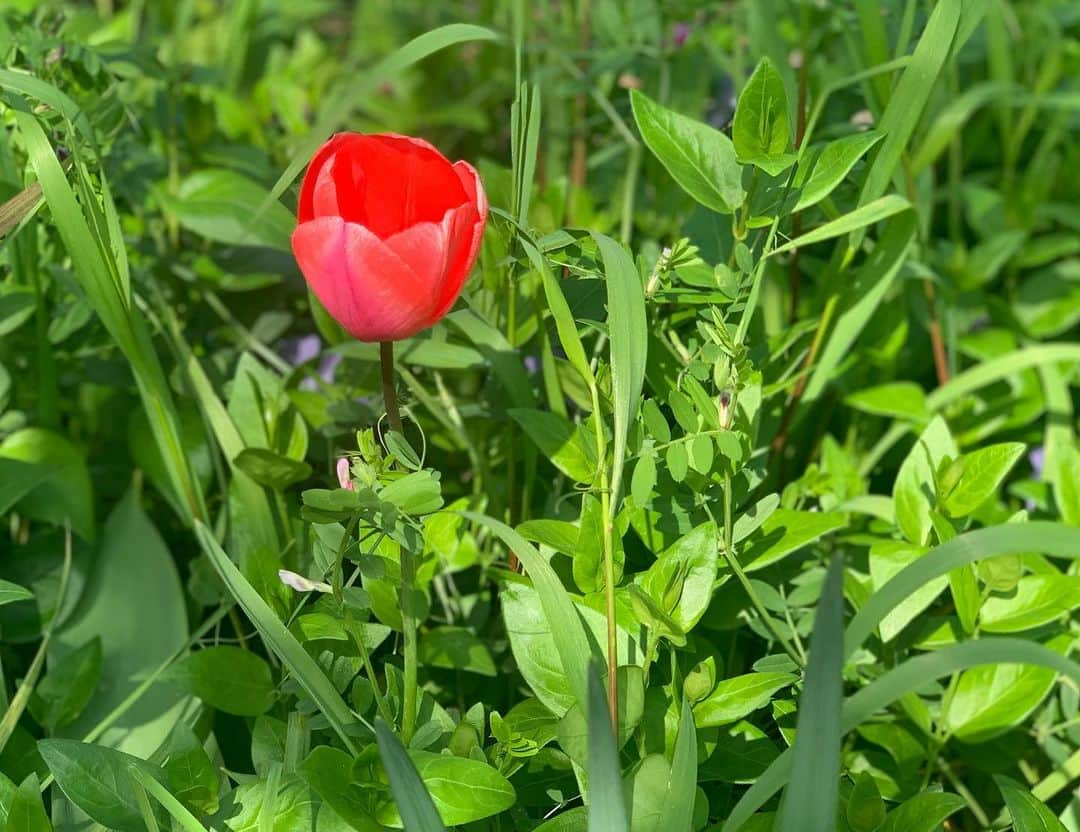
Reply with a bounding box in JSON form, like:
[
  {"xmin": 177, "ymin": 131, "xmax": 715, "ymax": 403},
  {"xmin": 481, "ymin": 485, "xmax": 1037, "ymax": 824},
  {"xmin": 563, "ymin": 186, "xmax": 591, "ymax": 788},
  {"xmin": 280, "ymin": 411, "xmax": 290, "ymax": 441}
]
[{"xmin": 293, "ymin": 217, "xmax": 433, "ymax": 341}]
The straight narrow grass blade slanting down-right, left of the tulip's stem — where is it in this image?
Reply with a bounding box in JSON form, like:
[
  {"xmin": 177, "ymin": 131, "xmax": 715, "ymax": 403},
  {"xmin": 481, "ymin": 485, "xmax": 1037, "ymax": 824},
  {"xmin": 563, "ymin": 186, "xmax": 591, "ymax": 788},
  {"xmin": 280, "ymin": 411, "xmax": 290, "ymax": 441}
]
[{"xmin": 195, "ymin": 523, "xmax": 356, "ymax": 753}]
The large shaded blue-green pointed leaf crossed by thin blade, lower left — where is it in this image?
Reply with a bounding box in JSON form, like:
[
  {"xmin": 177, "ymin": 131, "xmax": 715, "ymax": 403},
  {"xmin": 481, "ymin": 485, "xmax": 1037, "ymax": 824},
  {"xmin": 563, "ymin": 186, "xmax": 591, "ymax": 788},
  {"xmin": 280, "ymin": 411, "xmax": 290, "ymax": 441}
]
[{"xmin": 49, "ymin": 488, "xmax": 188, "ymax": 756}]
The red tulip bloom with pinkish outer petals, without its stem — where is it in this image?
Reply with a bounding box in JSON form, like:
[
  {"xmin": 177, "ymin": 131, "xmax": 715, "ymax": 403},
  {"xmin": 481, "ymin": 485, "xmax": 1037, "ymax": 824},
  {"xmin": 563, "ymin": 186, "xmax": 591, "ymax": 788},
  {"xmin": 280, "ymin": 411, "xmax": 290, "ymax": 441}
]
[{"xmin": 293, "ymin": 133, "xmax": 487, "ymax": 341}]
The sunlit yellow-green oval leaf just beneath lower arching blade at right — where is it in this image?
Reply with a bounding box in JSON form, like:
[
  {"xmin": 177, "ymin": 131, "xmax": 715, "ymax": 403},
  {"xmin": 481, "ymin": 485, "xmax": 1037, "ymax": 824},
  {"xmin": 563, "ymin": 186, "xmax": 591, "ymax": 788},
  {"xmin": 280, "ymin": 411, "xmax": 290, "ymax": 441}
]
[{"xmin": 945, "ymin": 635, "xmax": 1072, "ymax": 742}]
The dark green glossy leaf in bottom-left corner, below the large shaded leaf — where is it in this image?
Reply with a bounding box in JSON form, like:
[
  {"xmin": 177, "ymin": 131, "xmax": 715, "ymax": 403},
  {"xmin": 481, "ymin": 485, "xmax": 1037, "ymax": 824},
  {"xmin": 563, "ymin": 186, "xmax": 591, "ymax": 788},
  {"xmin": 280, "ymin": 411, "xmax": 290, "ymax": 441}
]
[{"xmin": 38, "ymin": 739, "xmax": 166, "ymax": 832}]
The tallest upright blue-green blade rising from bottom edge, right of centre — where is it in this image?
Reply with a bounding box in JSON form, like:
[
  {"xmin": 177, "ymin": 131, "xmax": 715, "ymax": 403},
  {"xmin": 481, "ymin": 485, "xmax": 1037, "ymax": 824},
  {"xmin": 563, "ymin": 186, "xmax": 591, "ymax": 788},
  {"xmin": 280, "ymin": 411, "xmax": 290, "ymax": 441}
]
[{"xmin": 780, "ymin": 554, "xmax": 846, "ymax": 832}]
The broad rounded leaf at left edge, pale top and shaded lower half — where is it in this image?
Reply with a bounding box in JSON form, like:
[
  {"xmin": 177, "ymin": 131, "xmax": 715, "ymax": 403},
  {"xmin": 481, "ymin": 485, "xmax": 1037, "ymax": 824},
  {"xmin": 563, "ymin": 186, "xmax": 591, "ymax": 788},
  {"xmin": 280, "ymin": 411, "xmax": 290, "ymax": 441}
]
[{"xmin": 0, "ymin": 428, "xmax": 94, "ymax": 540}]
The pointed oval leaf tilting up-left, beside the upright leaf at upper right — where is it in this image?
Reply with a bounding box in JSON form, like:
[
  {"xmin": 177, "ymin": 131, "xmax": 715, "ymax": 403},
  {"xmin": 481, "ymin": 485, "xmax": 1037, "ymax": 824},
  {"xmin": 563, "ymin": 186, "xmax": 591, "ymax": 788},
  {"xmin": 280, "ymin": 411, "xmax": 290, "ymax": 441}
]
[{"xmin": 630, "ymin": 90, "xmax": 746, "ymax": 214}]
